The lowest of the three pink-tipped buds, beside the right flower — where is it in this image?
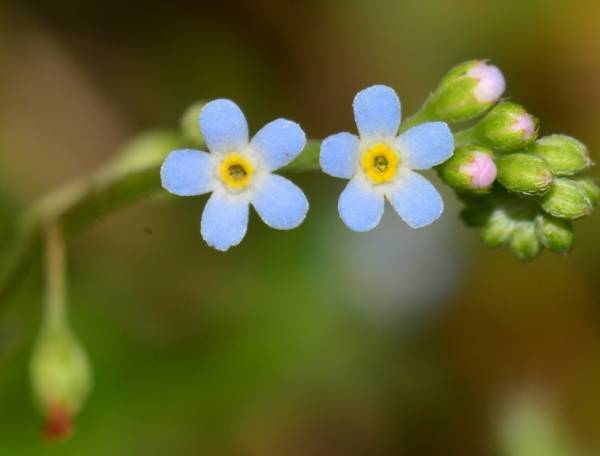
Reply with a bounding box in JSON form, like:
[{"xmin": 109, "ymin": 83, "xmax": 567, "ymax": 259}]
[{"xmin": 438, "ymin": 145, "xmax": 497, "ymax": 193}]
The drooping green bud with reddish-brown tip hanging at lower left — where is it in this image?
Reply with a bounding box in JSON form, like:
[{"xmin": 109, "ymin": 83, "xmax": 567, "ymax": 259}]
[{"xmin": 31, "ymin": 325, "xmax": 91, "ymax": 439}]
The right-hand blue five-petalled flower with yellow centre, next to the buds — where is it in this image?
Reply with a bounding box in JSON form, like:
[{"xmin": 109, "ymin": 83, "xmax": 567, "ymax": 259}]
[{"xmin": 320, "ymin": 85, "xmax": 454, "ymax": 231}]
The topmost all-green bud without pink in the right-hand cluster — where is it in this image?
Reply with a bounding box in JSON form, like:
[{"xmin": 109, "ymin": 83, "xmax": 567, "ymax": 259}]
[{"xmin": 530, "ymin": 135, "xmax": 592, "ymax": 176}]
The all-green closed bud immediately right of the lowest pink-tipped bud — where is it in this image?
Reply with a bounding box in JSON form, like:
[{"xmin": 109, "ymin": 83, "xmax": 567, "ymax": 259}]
[{"xmin": 496, "ymin": 153, "xmax": 552, "ymax": 195}]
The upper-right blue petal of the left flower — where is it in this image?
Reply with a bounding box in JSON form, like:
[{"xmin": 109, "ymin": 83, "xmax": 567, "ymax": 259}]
[{"xmin": 250, "ymin": 119, "xmax": 306, "ymax": 170}]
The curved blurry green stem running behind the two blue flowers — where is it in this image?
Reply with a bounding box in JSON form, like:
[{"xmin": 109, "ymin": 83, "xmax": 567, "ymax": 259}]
[{"xmin": 0, "ymin": 132, "xmax": 319, "ymax": 306}]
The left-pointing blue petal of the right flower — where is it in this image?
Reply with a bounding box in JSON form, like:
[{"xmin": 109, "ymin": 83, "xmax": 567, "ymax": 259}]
[{"xmin": 319, "ymin": 133, "xmax": 358, "ymax": 179}]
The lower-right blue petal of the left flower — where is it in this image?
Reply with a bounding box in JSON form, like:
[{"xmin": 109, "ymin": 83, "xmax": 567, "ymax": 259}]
[{"xmin": 252, "ymin": 174, "xmax": 308, "ymax": 230}]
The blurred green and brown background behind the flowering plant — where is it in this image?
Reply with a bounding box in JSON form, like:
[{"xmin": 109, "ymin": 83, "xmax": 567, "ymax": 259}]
[{"xmin": 0, "ymin": 0, "xmax": 600, "ymax": 456}]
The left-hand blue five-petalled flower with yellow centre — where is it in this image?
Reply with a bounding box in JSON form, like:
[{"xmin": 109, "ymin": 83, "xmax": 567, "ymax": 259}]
[{"xmin": 160, "ymin": 99, "xmax": 308, "ymax": 251}]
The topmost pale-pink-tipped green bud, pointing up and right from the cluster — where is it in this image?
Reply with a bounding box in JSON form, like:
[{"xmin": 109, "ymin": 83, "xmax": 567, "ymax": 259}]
[{"xmin": 422, "ymin": 60, "xmax": 506, "ymax": 123}]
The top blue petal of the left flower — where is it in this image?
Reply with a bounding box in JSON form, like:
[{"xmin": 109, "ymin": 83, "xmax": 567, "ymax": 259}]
[{"xmin": 200, "ymin": 99, "xmax": 248, "ymax": 153}]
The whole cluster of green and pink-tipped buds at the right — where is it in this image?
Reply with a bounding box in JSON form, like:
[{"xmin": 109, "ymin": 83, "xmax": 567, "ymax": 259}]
[{"xmin": 424, "ymin": 61, "xmax": 600, "ymax": 261}]
